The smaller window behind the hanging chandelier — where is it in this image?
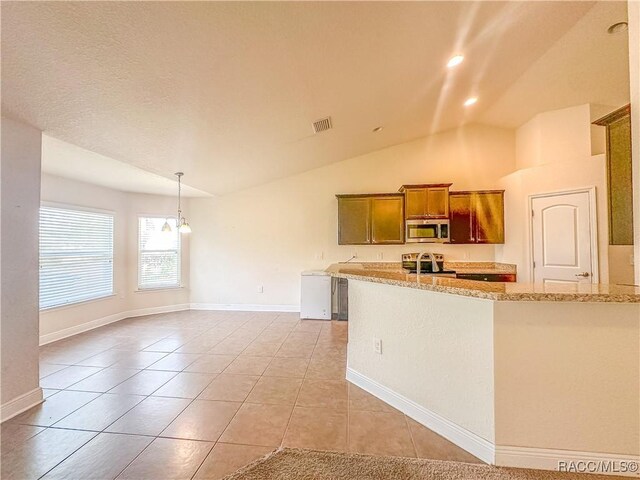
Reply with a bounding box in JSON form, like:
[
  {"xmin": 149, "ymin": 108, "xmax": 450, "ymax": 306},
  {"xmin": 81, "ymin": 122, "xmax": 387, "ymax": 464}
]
[{"xmin": 138, "ymin": 217, "xmax": 180, "ymax": 290}]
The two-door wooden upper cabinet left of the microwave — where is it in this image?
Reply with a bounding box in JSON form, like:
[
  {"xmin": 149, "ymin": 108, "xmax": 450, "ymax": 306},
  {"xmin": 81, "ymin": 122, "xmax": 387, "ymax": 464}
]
[{"xmin": 336, "ymin": 193, "xmax": 404, "ymax": 245}]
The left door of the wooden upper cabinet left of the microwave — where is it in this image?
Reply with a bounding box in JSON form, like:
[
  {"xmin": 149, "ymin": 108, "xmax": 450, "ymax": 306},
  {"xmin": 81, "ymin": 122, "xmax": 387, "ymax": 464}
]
[{"xmin": 338, "ymin": 197, "xmax": 371, "ymax": 245}]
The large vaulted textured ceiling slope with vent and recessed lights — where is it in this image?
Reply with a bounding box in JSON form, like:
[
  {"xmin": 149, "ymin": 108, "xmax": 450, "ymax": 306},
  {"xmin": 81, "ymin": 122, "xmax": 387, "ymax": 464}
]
[{"xmin": 2, "ymin": 1, "xmax": 625, "ymax": 194}]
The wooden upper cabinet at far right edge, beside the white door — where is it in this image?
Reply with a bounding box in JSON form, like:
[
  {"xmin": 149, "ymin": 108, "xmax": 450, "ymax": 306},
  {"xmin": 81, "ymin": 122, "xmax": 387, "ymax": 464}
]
[{"xmin": 593, "ymin": 105, "xmax": 633, "ymax": 245}]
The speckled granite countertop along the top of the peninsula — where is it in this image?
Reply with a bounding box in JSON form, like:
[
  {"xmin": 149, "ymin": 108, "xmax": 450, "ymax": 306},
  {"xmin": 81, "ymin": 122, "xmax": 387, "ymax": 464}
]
[{"xmin": 326, "ymin": 262, "xmax": 640, "ymax": 303}]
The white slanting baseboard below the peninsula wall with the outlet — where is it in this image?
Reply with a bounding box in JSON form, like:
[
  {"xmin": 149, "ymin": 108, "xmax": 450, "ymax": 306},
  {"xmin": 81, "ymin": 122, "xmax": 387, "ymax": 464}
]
[{"xmin": 347, "ymin": 367, "xmax": 495, "ymax": 464}]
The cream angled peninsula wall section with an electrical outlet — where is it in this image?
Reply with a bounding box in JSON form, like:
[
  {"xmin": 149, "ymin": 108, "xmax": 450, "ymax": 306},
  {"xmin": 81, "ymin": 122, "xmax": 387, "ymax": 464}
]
[{"xmin": 347, "ymin": 280, "xmax": 495, "ymax": 443}]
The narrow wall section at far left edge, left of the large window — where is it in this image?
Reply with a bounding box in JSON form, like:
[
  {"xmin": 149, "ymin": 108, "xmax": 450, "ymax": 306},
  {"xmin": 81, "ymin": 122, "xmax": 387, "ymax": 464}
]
[{"xmin": 0, "ymin": 117, "xmax": 41, "ymax": 408}]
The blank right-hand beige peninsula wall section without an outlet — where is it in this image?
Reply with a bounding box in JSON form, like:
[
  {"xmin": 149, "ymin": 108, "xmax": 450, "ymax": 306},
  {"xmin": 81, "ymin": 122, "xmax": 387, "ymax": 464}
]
[{"xmin": 494, "ymin": 302, "xmax": 640, "ymax": 455}]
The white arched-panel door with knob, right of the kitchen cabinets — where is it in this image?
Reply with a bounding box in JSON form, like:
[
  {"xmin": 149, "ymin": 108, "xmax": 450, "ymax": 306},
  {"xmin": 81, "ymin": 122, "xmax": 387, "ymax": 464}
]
[{"xmin": 531, "ymin": 191, "xmax": 595, "ymax": 284}]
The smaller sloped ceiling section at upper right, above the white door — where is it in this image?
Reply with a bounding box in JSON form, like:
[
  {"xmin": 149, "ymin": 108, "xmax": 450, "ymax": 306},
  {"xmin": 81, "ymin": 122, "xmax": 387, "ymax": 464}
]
[{"xmin": 480, "ymin": 2, "xmax": 630, "ymax": 127}]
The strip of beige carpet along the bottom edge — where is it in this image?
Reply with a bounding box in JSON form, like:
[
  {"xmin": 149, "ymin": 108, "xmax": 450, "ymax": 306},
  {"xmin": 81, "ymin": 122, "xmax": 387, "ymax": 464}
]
[{"xmin": 223, "ymin": 448, "xmax": 623, "ymax": 480}]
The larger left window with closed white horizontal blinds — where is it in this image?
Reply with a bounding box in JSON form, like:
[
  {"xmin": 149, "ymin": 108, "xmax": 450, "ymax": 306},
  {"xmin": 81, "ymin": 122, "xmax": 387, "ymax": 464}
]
[{"xmin": 40, "ymin": 206, "xmax": 113, "ymax": 310}]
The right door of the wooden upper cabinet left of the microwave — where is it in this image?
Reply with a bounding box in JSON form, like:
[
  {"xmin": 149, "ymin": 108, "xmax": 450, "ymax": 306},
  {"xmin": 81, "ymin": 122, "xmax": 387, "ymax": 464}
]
[{"xmin": 371, "ymin": 195, "xmax": 404, "ymax": 244}]
